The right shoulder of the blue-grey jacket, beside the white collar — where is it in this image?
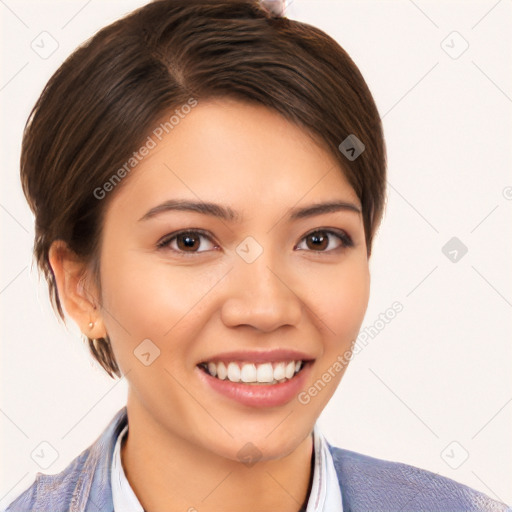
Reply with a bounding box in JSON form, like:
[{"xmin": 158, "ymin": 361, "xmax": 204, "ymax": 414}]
[{"xmin": 329, "ymin": 445, "xmax": 512, "ymax": 512}]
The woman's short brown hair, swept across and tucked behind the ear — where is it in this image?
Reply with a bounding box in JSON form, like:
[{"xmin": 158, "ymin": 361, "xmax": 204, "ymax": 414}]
[{"xmin": 21, "ymin": 0, "xmax": 386, "ymax": 377}]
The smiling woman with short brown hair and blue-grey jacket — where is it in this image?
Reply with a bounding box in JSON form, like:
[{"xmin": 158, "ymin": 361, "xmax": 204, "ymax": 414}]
[{"xmin": 7, "ymin": 0, "xmax": 506, "ymax": 512}]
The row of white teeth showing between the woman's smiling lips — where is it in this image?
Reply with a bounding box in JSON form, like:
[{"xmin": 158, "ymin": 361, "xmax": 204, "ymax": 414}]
[{"xmin": 197, "ymin": 360, "xmax": 310, "ymax": 385}]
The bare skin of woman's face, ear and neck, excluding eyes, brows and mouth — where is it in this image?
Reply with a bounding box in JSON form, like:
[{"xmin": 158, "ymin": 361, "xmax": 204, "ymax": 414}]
[{"xmin": 50, "ymin": 99, "xmax": 370, "ymax": 512}]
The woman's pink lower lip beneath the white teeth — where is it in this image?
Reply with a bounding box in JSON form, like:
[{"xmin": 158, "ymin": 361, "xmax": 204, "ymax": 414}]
[{"xmin": 196, "ymin": 361, "xmax": 313, "ymax": 407}]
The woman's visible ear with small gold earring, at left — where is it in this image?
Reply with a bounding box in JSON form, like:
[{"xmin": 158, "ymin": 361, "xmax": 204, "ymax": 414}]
[{"xmin": 48, "ymin": 240, "xmax": 107, "ymax": 338}]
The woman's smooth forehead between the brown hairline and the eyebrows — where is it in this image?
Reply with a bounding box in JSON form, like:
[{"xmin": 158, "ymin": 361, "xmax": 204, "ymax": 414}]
[{"xmin": 105, "ymin": 98, "xmax": 360, "ymax": 220}]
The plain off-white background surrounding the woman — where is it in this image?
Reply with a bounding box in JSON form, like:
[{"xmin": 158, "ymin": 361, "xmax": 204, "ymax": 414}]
[{"xmin": 0, "ymin": 0, "xmax": 512, "ymax": 506}]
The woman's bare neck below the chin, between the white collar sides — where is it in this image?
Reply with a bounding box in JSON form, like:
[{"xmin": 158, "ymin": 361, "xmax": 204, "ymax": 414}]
[{"xmin": 121, "ymin": 394, "xmax": 314, "ymax": 512}]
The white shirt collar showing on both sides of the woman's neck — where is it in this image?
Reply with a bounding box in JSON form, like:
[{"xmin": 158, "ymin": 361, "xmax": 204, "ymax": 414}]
[{"xmin": 111, "ymin": 423, "xmax": 343, "ymax": 512}]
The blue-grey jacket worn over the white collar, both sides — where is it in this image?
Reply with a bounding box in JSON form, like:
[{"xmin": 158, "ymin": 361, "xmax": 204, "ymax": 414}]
[{"xmin": 6, "ymin": 407, "xmax": 512, "ymax": 512}]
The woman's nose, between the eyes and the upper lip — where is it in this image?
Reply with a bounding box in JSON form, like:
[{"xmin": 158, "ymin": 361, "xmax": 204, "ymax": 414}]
[{"xmin": 221, "ymin": 255, "xmax": 302, "ymax": 332}]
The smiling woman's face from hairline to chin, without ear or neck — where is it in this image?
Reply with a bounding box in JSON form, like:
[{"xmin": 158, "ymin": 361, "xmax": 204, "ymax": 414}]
[{"xmin": 100, "ymin": 99, "xmax": 370, "ymax": 460}]
